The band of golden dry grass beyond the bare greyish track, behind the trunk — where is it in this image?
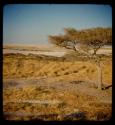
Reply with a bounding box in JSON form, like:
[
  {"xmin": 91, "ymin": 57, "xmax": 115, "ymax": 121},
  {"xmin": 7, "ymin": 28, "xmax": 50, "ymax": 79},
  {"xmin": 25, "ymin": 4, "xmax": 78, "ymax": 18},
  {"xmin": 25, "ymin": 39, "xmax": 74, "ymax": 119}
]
[{"xmin": 3, "ymin": 55, "xmax": 112, "ymax": 84}]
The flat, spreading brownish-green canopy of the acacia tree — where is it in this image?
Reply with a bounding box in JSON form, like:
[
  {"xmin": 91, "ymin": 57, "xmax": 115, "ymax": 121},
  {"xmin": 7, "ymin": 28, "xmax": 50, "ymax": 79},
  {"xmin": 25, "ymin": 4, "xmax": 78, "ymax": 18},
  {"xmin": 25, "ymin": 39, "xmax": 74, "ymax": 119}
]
[{"xmin": 49, "ymin": 27, "xmax": 112, "ymax": 54}]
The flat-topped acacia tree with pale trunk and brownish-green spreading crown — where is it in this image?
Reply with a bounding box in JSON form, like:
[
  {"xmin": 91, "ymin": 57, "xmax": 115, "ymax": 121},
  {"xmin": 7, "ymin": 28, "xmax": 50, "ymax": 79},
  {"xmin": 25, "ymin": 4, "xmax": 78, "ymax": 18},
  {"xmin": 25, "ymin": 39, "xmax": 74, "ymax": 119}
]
[{"xmin": 49, "ymin": 27, "xmax": 112, "ymax": 89}]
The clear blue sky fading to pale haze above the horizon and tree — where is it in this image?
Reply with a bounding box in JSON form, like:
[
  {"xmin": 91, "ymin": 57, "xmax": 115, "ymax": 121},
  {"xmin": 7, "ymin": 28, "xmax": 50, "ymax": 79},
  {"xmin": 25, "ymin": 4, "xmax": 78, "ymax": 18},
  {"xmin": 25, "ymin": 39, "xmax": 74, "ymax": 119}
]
[{"xmin": 3, "ymin": 4, "xmax": 112, "ymax": 44}]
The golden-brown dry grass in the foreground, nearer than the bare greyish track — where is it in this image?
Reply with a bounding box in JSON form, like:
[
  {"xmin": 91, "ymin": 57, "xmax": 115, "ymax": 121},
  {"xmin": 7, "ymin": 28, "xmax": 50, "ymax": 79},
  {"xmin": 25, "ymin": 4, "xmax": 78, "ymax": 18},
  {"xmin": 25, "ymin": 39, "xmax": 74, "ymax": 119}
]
[{"xmin": 3, "ymin": 86, "xmax": 111, "ymax": 120}]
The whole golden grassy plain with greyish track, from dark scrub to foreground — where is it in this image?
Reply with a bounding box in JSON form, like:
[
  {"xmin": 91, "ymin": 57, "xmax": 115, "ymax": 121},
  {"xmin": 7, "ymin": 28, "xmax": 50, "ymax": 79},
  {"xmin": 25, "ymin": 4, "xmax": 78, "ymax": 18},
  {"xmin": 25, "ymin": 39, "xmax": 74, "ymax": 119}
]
[{"xmin": 3, "ymin": 46, "xmax": 112, "ymax": 121}]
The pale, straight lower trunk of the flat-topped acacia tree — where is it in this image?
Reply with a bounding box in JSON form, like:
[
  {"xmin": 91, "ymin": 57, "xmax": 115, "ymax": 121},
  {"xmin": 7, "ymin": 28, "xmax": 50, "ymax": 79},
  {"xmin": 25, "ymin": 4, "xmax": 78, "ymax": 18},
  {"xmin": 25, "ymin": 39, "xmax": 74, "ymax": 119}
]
[{"xmin": 97, "ymin": 62, "xmax": 102, "ymax": 90}]
